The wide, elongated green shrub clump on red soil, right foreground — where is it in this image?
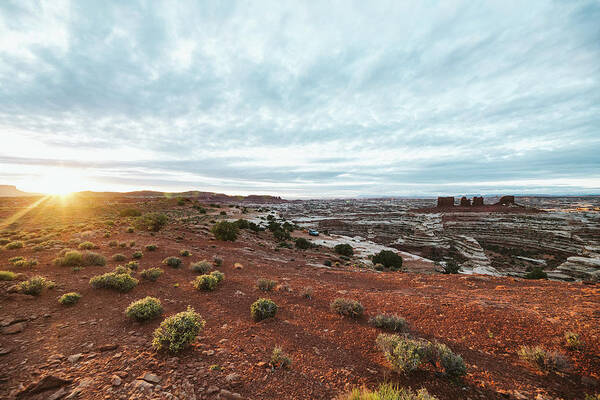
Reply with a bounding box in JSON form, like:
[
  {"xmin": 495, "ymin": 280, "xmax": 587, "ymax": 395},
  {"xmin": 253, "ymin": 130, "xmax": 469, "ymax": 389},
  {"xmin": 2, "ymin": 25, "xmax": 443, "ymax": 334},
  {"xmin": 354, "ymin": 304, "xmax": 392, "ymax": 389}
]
[{"xmin": 376, "ymin": 334, "xmax": 467, "ymax": 378}]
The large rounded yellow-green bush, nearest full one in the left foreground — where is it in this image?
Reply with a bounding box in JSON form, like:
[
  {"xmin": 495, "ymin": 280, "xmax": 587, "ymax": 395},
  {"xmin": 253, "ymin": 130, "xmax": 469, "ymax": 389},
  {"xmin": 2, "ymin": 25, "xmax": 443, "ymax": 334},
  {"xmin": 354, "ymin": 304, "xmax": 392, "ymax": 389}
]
[{"xmin": 152, "ymin": 306, "xmax": 205, "ymax": 353}]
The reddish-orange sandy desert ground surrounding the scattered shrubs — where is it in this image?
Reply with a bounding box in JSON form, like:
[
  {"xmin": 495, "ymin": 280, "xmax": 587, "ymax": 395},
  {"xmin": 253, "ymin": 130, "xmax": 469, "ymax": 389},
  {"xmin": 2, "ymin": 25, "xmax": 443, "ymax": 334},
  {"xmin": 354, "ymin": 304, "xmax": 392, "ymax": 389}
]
[{"xmin": 0, "ymin": 195, "xmax": 600, "ymax": 399}]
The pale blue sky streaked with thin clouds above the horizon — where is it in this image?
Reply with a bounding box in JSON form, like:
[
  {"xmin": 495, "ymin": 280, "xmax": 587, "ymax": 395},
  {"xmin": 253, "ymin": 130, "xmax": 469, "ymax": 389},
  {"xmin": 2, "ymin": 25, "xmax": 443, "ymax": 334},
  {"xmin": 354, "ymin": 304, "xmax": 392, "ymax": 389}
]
[{"xmin": 0, "ymin": 0, "xmax": 600, "ymax": 198}]
